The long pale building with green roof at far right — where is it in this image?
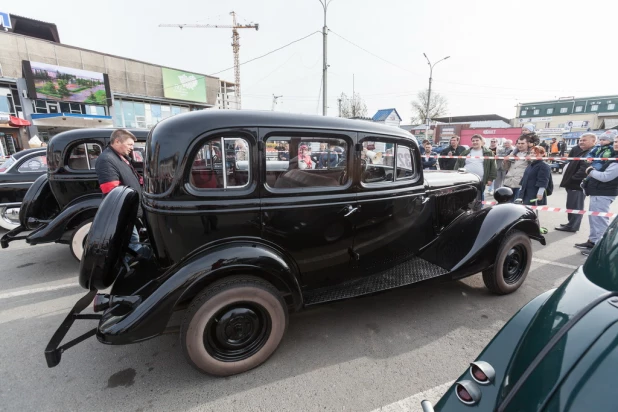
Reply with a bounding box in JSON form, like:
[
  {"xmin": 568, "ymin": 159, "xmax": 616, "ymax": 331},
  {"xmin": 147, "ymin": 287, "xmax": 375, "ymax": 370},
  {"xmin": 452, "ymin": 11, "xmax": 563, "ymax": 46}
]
[{"xmin": 512, "ymin": 95, "xmax": 618, "ymax": 133}]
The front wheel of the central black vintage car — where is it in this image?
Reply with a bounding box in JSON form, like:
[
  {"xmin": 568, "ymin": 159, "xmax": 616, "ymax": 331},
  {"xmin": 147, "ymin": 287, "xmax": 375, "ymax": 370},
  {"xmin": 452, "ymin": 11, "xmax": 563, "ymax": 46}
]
[{"xmin": 483, "ymin": 230, "xmax": 532, "ymax": 295}]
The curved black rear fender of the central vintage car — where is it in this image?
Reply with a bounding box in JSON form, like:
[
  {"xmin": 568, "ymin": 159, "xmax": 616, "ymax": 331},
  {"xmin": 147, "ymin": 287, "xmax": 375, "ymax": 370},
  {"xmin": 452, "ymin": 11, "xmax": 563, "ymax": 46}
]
[{"xmin": 97, "ymin": 240, "xmax": 302, "ymax": 344}]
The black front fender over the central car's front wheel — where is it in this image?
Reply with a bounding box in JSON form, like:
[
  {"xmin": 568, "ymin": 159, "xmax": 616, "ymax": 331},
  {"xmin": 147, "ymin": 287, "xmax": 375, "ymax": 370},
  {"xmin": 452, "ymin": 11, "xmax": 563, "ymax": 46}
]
[{"xmin": 420, "ymin": 203, "xmax": 545, "ymax": 276}]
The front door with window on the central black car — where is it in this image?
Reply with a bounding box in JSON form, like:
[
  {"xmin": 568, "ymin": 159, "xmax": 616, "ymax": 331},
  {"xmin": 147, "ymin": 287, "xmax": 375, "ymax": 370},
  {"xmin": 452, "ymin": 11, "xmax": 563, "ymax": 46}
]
[{"xmin": 353, "ymin": 134, "xmax": 433, "ymax": 276}]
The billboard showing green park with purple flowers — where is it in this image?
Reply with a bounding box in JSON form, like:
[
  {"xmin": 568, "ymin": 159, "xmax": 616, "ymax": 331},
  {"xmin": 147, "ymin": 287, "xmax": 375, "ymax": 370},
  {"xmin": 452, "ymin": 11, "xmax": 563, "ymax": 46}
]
[{"xmin": 24, "ymin": 62, "xmax": 111, "ymax": 105}]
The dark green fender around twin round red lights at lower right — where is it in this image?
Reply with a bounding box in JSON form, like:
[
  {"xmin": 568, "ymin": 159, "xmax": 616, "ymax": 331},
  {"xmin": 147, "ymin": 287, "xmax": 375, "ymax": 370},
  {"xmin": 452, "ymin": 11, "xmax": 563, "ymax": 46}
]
[{"xmin": 435, "ymin": 289, "xmax": 556, "ymax": 412}]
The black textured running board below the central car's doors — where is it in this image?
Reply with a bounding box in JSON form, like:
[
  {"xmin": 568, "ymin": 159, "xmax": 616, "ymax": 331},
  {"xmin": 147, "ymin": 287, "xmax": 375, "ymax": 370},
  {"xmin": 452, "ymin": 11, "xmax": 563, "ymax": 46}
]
[{"xmin": 303, "ymin": 257, "xmax": 448, "ymax": 306}]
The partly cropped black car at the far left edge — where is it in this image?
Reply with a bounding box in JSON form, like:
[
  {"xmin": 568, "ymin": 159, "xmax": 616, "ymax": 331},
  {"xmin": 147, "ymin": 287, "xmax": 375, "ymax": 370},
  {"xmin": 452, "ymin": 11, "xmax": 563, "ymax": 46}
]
[{"xmin": 0, "ymin": 148, "xmax": 47, "ymax": 230}]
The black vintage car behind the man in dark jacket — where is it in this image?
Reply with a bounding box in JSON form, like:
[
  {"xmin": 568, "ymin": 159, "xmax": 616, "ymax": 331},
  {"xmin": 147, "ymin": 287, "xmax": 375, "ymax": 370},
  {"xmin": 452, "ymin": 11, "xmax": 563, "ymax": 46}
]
[{"xmin": 0, "ymin": 129, "xmax": 148, "ymax": 260}]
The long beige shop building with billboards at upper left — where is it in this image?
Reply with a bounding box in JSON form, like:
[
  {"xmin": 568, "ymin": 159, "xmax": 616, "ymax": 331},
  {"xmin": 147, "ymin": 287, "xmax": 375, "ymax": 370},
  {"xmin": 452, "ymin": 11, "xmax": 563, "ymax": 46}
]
[{"xmin": 0, "ymin": 15, "xmax": 237, "ymax": 150}]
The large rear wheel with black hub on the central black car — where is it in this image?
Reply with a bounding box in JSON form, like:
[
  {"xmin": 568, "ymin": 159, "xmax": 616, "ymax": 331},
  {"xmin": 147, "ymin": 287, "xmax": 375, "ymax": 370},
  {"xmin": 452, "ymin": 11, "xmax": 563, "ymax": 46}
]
[{"xmin": 180, "ymin": 276, "xmax": 288, "ymax": 376}]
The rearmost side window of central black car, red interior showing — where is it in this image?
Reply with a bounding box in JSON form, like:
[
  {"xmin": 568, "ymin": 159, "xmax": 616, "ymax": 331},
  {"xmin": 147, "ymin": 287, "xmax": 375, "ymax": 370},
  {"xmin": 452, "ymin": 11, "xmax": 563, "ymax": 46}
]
[{"xmin": 189, "ymin": 137, "xmax": 251, "ymax": 189}]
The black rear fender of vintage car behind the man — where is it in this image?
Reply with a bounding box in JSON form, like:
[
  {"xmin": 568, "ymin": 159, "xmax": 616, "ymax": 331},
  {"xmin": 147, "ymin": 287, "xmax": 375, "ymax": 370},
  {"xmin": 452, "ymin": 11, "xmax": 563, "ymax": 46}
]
[{"xmin": 26, "ymin": 193, "xmax": 103, "ymax": 245}]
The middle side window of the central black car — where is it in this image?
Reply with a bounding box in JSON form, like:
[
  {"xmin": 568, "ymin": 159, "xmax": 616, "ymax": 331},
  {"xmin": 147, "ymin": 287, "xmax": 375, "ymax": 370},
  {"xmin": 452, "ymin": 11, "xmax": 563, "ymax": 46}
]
[{"xmin": 266, "ymin": 136, "xmax": 349, "ymax": 189}]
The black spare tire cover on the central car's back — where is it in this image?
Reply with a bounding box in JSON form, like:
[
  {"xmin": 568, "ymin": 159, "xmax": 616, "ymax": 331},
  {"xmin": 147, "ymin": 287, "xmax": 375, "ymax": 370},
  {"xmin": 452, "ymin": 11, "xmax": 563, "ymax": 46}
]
[{"xmin": 79, "ymin": 186, "xmax": 139, "ymax": 290}]
